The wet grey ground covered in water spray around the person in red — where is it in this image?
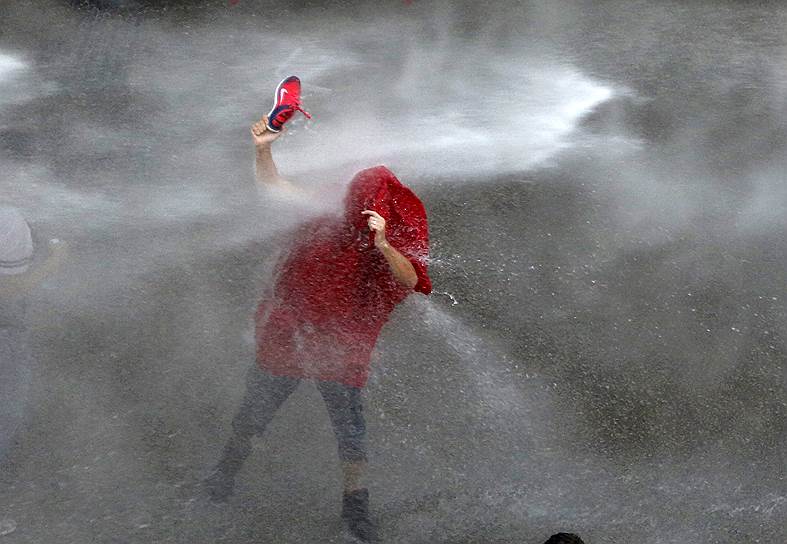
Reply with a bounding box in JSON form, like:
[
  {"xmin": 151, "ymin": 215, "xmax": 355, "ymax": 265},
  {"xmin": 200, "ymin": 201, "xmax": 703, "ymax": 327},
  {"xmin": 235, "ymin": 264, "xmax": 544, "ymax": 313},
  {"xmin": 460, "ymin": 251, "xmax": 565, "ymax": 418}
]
[{"xmin": 0, "ymin": 0, "xmax": 787, "ymax": 543}]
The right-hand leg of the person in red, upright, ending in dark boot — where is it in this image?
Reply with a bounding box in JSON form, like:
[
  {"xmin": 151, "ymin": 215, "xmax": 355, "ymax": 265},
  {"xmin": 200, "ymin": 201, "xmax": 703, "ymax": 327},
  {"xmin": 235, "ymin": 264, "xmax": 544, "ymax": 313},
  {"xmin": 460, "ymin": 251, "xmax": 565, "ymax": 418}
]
[{"xmin": 317, "ymin": 381, "xmax": 377, "ymax": 542}]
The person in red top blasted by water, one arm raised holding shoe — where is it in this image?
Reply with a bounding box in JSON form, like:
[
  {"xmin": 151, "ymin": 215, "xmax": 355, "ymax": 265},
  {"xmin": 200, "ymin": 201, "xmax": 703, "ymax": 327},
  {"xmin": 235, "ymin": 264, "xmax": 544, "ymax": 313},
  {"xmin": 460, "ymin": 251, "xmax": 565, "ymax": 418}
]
[{"xmin": 207, "ymin": 119, "xmax": 432, "ymax": 541}]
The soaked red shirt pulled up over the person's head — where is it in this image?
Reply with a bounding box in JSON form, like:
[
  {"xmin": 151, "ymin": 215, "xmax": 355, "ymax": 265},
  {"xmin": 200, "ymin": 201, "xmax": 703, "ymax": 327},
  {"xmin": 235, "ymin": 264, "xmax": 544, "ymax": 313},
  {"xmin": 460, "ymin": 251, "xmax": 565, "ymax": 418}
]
[{"xmin": 256, "ymin": 166, "xmax": 432, "ymax": 387}]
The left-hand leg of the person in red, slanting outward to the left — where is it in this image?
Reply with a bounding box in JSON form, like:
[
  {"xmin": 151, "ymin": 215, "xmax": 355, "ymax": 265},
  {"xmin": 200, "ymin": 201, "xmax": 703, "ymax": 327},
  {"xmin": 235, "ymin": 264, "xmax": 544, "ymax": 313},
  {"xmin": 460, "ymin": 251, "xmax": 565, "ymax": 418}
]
[{"xmin": 207, "ymin": 364, "xmax": 299, "ymax": 500}]
